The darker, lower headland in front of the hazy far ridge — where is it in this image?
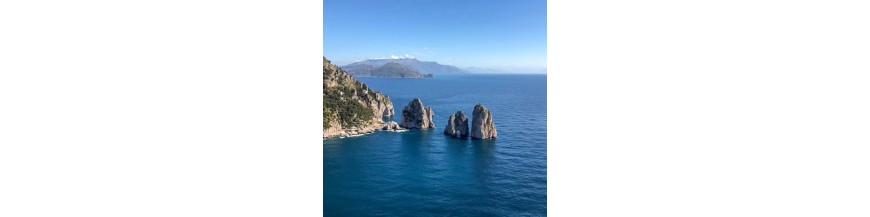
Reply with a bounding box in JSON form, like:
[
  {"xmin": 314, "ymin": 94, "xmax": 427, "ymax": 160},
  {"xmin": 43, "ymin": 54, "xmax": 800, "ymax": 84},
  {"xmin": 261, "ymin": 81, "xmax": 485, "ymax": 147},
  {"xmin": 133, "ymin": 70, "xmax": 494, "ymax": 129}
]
[{"xmin": 342, "ymin": 62, "xmax": 433, "ymax": 78}]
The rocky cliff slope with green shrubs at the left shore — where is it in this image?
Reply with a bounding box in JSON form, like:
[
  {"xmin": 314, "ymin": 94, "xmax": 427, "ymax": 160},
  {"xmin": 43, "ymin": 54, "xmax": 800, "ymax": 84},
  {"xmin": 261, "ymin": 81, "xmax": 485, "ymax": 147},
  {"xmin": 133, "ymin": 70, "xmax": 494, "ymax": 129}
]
[{"xmin": 323, "ymin": 57, "xmax": 395, "ymax": 138}]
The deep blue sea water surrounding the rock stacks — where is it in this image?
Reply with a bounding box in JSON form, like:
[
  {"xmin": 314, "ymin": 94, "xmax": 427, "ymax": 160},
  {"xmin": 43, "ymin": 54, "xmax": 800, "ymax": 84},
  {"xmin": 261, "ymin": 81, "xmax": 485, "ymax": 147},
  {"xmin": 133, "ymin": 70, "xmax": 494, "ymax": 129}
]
[{"xmin": 323, "ymin": 75, "xmax": 547, "ymax": 216}]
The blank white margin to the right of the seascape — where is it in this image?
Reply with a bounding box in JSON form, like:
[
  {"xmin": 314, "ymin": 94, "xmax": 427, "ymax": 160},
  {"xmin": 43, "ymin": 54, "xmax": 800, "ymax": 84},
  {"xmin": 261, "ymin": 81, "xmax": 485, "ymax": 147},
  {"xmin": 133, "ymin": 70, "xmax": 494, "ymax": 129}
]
[{"xmin": 547, "ymin": 0, "xmax": 870, "ymax": 216}]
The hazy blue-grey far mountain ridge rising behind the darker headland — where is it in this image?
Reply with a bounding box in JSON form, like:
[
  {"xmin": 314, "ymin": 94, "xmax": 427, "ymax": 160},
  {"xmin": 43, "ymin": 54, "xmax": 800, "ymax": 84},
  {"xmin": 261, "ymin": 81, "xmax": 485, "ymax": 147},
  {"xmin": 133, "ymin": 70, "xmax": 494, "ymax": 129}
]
[{"xmin": 341, "ymin": 58, "xmax": 468, "ymax": 75}]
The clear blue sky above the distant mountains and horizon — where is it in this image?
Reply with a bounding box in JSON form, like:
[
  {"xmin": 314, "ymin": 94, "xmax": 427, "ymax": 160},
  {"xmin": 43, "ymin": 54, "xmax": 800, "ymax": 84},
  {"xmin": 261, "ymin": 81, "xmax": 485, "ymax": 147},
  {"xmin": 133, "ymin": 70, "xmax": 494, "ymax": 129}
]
[{"xmin": 323, "ymin": 0, "xmax": 547, "ymax": 73}]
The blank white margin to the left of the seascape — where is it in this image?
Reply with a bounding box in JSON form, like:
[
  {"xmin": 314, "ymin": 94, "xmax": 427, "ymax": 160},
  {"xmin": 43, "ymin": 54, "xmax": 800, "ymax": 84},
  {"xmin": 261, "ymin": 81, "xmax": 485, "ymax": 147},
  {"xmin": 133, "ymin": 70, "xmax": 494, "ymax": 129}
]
[{"xmin": 0, "ymin": 0, "xmax": 323, "ymax": 217}]
